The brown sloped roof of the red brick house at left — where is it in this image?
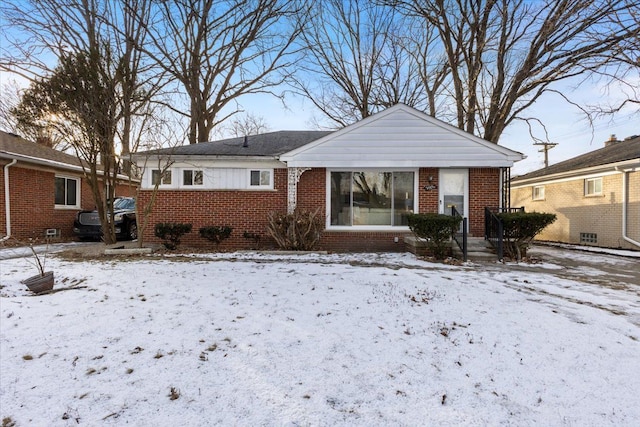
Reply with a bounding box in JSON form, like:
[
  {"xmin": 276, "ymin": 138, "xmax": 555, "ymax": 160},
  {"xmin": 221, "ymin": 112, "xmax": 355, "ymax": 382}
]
[{"xmin": 0, "ymin": 131, "xmax": 82, "ymax": 170}]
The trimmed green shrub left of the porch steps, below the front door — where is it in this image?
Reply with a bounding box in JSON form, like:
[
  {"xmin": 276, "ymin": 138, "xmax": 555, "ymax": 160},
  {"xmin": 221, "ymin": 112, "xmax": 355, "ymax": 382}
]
[{"xmin": 407, "ymin": 213, "xmax": 462, "ymax": 259}]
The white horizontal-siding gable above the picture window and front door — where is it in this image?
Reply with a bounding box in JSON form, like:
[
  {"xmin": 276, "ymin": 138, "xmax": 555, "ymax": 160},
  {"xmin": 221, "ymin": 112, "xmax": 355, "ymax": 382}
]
[{"xmin": 280, "ymin": 104, "xmax": 523, "ymax": 168}]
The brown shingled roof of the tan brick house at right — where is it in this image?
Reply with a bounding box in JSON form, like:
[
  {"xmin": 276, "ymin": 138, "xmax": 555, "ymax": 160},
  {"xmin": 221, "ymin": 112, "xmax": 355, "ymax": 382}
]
[{"xmin": 511, "ymin": 135, "xmax": 640, "ymax": 183}]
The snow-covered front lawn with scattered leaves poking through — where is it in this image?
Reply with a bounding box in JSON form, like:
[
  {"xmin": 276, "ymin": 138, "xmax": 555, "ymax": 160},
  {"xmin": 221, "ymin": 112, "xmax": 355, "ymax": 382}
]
[{"xmin": 0, "ymin": 249, "xmax": 640, "ymax": 426}]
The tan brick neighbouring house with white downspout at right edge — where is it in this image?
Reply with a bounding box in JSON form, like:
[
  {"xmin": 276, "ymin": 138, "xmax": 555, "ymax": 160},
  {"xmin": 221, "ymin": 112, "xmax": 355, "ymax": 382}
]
[{"xmin": 511, "ymin": 135, "xmax": 640, "ymax": 250}]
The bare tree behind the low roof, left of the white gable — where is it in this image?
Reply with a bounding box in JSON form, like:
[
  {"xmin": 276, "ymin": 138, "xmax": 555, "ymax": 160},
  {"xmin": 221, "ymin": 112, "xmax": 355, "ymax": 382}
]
[{"xmin": 134, "ymin": 0, "xmax": 300, "ymax": 144}]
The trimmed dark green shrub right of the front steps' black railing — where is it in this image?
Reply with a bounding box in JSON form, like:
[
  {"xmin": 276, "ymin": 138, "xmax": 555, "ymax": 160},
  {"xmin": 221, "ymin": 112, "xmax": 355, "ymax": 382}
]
[{"xmin": 498, "ymin": 212, "xmax": 556, "ymax": 261}]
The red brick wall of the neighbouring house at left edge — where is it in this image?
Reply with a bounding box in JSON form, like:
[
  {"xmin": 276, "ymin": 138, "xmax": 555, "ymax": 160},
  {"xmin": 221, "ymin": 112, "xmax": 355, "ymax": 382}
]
[{"xmin": 0, "ymin": 162, "xmax": 135, "ymax": 239}]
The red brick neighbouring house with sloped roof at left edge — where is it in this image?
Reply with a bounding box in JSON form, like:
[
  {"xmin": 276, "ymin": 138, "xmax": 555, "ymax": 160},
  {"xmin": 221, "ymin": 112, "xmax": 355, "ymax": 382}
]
[{"xmin": 0, "ymin": 131, "xmax": 136, "ymax": 241}]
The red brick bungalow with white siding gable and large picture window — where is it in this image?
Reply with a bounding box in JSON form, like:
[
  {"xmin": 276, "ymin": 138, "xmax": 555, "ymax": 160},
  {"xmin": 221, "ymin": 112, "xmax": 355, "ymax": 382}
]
[{"xmin": 134, "ymin": 104, "xmax": 523, "ymax": 251}]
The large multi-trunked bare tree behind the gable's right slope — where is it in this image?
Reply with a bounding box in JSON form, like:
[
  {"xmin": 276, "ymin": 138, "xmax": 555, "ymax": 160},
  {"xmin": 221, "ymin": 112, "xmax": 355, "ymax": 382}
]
[{"xmin": 390, "ymin": 0, "xmax": 639, "ymax": 143}]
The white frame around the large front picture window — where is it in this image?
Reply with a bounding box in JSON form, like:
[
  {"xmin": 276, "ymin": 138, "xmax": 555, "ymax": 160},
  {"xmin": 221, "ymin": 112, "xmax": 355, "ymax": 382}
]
[{"xmin": 325, "ymin": 167, "xmax": 420, "ymax": 232}]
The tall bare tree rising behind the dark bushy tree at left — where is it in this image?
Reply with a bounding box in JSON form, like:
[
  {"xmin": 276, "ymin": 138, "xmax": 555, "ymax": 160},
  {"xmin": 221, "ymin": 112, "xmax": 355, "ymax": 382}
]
[{"xmin": 0, "ymin": 0, "xmax": 162, "ymax": 172}]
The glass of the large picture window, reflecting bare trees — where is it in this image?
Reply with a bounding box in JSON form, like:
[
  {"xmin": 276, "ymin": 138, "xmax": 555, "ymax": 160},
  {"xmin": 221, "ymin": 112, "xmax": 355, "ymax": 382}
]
[{"xmin": 330, "ymin": 171, "xmax": 415, "ymax": 227}]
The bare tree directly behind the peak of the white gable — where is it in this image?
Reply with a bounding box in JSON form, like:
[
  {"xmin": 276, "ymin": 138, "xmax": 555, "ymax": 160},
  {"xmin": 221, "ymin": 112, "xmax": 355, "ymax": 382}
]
[{"xmin": 293, "ymin": 0, "xmax": 398, "ymax": 127}]
